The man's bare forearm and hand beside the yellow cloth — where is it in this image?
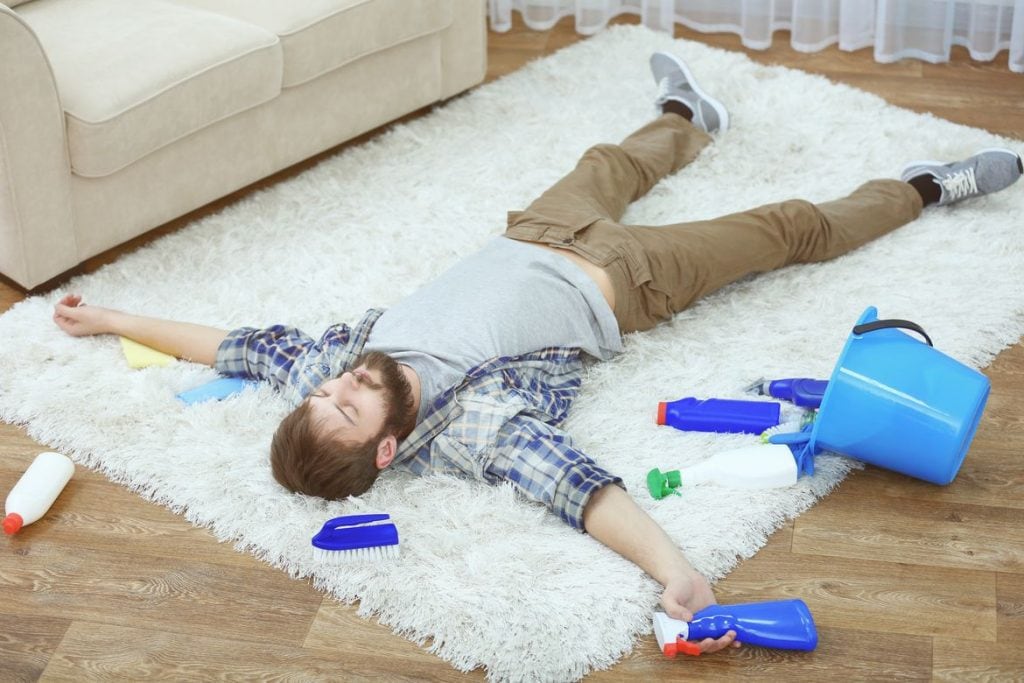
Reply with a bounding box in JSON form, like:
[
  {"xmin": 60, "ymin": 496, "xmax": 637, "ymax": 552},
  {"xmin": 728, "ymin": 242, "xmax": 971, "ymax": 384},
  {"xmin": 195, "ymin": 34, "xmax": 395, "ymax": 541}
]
[{"xmin": 53, "ymin": 294, "xmax": 227, "ymax": 367}]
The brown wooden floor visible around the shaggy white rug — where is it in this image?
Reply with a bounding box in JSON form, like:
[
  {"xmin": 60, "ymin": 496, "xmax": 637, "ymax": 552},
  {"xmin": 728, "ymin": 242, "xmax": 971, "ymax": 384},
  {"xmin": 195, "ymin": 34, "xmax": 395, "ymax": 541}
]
[{"xmin": 0, "ymin": 12, "xmax": 1024, "ymax": 681}]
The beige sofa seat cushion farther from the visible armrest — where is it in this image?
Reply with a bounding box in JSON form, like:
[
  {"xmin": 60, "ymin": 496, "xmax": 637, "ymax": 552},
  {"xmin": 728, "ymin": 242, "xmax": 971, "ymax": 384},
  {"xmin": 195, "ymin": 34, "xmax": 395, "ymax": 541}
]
[{"xmin": 165, "ymin": 0, "xmax": 452, "ymax": 87}]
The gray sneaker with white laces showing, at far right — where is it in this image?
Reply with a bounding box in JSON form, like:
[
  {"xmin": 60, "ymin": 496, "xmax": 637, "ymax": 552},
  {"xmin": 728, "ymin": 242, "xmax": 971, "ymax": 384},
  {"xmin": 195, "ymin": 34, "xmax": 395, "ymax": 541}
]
[{"xmin": 900, "ymin": 148, "xmax": 1024, "ymax": 206}]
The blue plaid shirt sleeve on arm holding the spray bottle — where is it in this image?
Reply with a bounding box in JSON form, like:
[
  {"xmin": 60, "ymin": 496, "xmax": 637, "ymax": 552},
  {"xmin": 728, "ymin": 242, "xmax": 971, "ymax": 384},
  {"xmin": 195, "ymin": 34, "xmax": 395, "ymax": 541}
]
[{"xmin": 483, "ymin": 414, "xmax": 625, "ymax": 531}]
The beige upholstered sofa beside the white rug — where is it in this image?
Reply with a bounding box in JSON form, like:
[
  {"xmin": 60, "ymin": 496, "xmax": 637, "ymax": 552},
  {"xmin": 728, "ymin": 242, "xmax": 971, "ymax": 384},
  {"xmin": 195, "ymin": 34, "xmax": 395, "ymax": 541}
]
[{"xmin": 0, "ymin": 0, "xmax": 486, "ymax": 288}]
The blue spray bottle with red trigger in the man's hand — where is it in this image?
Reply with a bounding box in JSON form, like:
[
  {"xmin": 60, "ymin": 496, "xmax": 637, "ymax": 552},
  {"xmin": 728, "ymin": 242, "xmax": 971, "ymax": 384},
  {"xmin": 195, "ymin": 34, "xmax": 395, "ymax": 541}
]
[{"xmin": 654, "ymin": 600, "xmax": 818, "ymax": 657}]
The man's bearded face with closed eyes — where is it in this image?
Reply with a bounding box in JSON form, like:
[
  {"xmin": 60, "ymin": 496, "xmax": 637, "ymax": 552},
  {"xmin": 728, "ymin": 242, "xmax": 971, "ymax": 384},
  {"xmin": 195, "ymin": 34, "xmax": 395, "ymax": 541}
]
[{"xmin": 307, "ymin": 353, "xmax": 415, "ymax": 443}]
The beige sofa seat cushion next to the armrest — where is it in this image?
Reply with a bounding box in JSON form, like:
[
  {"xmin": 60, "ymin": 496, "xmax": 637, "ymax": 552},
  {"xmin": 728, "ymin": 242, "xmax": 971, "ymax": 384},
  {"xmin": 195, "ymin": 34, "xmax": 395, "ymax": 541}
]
[{"xmin": 18, "ymin": 0, "xmax": 283, "ymax": 177}]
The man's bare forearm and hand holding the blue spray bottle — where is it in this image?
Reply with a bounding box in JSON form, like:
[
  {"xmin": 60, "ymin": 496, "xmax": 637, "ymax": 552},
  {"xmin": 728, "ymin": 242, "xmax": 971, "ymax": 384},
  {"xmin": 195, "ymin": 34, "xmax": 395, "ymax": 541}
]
[{"xmin": 583, "ymin": 485, "xmax": 736, "ymax": 652}]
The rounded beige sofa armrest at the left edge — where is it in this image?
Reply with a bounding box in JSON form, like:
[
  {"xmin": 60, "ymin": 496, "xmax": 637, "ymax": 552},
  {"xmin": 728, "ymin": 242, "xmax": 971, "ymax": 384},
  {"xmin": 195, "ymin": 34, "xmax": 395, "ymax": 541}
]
[{"xmin": 0, "ymin": 5, "xmax": 79, "ymax": 289}]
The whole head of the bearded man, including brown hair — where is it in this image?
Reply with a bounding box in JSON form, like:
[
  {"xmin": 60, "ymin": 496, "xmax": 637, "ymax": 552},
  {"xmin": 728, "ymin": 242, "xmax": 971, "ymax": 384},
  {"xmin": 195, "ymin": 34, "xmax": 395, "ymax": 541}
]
[{"xmin": 270, "ymin": 351, "xmax": 416, "ymax": 500}]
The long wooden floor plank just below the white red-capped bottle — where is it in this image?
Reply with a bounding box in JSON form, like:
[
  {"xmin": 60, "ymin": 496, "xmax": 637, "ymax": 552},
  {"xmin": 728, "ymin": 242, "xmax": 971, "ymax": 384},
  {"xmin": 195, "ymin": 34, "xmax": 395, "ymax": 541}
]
[{"xmin": 0, "ymin": 536, "xmax": 323, "ymax": 646}]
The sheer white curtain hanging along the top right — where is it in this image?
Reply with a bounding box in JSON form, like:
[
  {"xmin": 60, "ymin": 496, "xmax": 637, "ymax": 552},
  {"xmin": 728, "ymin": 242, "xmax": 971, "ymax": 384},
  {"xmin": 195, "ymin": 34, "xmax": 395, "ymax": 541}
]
[{"xmin": 489, "ymin": 0, "xmax": 1024, "ymax": 73}]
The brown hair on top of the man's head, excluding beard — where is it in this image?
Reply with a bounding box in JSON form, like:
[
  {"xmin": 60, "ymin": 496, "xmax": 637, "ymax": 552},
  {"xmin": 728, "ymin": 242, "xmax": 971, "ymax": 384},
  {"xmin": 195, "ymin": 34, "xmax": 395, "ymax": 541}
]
[{"xmin": 270, "ymin": 401, "xmax": 383, "ymax": 500}]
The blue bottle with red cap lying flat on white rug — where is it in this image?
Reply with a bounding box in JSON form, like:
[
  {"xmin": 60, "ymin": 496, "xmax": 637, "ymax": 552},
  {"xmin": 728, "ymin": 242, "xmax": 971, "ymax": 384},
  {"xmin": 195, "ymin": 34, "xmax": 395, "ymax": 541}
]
[{"xmin": 657, "ymin": 396, "xmax": 781, "ymax": 434}]
